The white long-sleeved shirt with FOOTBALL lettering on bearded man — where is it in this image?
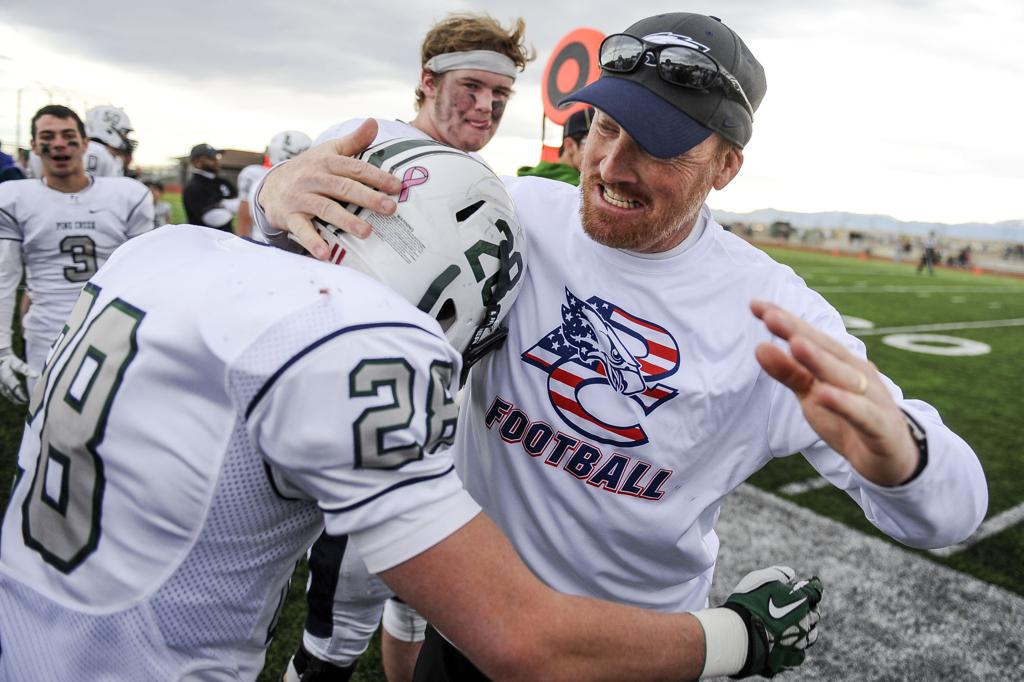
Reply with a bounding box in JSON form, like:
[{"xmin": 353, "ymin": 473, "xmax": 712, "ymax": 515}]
[{"xmin": 454, "ymin": 178, "xmax": 987, "ymax": 611}]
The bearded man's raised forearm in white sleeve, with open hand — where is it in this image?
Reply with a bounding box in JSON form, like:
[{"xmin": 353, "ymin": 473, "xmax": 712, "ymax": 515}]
[{"xmin": 752, "ymin": 301, "xmax": 988, "ymax": 548}]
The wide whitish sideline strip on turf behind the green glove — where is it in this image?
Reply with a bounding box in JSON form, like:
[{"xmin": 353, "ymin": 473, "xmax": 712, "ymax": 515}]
[{"xmin": 711, "ymin": 483, "xmax": 1024, "ymax": 682}]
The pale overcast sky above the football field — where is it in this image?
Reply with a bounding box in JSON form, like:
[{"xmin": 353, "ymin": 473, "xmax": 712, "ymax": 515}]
[{"xmin": 0, "ymin": 0, "xmax": 1024, "ymax": 222}]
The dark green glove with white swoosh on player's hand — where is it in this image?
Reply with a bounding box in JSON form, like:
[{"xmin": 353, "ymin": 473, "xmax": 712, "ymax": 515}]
[{"xmin": 722, "ymin": 566, "xmax": 822, "ymax": 678}]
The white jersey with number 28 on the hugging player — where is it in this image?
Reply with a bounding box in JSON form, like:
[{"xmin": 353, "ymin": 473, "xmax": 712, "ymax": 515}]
[{"xmin": 0, "ymin": 225, "xmax": 479, "ymax": 680}]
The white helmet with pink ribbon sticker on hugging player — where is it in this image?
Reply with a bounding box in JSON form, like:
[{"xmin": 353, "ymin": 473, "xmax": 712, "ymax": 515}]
[{"xmin": 316, "ymin": 138, "xmax": 526, "ymax": 368}]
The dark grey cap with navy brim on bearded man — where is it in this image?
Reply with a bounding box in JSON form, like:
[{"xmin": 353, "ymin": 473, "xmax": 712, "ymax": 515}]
[{"xmin": 559, "ymin": 12, "xmax": 768, "ymax": 159}]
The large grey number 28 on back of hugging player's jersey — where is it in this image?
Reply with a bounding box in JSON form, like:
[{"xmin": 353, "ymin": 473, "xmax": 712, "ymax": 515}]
[{"xmin": 23, "ymin": 285, "xmax": 145, "ymax": 573}]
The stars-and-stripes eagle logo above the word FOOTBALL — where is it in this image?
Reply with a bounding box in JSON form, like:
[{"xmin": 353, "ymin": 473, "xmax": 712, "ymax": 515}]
[{"xmin": 522, "ymin": 289, "xmax": 679, "ymax": 447}]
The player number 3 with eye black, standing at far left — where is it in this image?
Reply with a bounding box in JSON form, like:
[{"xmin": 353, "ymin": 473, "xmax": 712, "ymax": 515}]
[{"xmin": 0, "ymin": 104, "xmax": 153, "ymax": 402}]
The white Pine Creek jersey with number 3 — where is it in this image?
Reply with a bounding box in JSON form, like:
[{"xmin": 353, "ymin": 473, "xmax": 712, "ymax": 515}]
[{"xmin": 0, "ymin": 177, "xmax": 153, "ymax": 352}]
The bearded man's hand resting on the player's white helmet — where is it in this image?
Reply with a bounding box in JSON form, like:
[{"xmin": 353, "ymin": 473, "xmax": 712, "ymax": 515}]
[{"xmin": 257, "ymin": 119, "xmax": 401, "ymax": 260}]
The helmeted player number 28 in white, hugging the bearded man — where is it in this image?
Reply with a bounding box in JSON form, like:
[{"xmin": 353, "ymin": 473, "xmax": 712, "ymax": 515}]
[{"xmin": 0, "ymin": 126, "xmax": 821, "ymax": 682}]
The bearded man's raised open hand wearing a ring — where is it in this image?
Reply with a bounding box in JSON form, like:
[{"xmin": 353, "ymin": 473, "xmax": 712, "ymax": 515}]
[{"xmin": 751, "ymin": 301, "xmax": 920, "ymax": 485}]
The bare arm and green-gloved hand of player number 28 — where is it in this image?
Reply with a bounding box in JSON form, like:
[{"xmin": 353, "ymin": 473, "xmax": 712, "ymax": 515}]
[{"xmin": 380, "ymin": 514, "xmax": 821, "ymax": 680}]
